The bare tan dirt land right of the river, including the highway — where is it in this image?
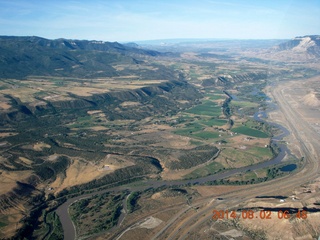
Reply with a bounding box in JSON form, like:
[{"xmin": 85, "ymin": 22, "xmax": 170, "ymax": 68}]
[{"xmin": 120, "ymin": 76, "xmax": 320, "ymax": 239}]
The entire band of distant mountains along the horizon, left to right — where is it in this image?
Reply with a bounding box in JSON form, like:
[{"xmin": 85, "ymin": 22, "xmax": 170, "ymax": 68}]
[{"xmin": 0, "ymin": 35, "xmax": 320, "ymax": 79}]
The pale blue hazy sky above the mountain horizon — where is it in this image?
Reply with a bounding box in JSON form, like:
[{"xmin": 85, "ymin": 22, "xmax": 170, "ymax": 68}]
[{"xmin": 0, "ymin": 0, "xmax": 320, "ymax": 42}]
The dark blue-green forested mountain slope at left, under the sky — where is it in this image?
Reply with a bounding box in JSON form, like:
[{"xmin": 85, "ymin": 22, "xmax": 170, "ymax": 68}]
[{"xmin": 0, "ymin": 36, "xmax": 161, "ymax": 79}]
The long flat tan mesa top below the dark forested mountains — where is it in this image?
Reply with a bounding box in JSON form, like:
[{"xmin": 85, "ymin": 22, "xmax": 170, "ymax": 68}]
[{"xmin": 0, "ymin": 75, "xmax": 167, "ymax": 106}]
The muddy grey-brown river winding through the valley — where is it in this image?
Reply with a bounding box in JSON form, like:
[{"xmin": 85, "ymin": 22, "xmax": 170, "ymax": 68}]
[{"xmin": 56, "ymin": 104, "xmax": 290, "ymax": 240}]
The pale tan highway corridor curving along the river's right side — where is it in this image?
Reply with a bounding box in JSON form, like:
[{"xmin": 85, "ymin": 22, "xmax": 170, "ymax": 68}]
[{"xmin": 153, "ymin": 79, "xmax": 320, "ymax": 239}]
